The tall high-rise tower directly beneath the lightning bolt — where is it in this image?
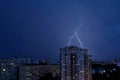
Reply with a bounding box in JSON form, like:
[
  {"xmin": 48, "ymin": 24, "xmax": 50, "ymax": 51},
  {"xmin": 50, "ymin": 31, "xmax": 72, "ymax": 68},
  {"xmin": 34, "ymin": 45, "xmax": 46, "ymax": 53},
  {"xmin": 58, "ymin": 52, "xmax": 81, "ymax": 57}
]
[{"xmin": 60, "ymin": 46, "xmax": 92, "ymax": 80}]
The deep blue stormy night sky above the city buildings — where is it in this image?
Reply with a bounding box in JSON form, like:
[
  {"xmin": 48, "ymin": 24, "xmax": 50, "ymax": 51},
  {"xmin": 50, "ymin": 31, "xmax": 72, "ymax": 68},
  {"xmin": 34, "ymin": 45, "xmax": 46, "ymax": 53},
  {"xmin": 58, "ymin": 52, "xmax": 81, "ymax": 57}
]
[{"xmin": 0, "ymin": 0, "xmax": 120, "ymax": 60}]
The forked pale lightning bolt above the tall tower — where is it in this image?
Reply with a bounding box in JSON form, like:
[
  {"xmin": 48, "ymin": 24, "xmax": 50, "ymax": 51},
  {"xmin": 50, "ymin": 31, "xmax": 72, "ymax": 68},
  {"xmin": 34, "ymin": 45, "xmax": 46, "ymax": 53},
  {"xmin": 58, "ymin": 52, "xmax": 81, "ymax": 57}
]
[{"xmin": 67, "ymin": 25, "xmax": 83, "ymax": 48}]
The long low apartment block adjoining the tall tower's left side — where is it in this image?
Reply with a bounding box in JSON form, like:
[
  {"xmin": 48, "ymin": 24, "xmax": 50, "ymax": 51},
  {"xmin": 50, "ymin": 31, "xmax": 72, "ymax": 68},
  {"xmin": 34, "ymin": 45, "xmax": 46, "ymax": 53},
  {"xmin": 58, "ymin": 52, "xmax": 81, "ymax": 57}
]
[{"xmin": 19, "ymin": 64, "xmax": 60, "ymax": 80}]
